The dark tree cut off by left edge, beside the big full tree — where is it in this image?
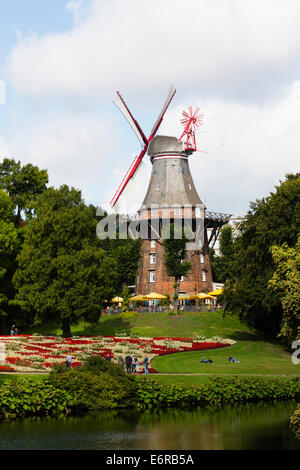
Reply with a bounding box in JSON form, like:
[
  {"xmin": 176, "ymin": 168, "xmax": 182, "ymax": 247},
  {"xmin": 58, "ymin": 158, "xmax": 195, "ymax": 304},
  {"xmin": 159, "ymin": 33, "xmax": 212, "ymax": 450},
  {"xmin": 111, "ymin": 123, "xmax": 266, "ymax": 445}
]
[{"xmin": 0, "ymin": 190, "xmax": 21, "ymax": 332}]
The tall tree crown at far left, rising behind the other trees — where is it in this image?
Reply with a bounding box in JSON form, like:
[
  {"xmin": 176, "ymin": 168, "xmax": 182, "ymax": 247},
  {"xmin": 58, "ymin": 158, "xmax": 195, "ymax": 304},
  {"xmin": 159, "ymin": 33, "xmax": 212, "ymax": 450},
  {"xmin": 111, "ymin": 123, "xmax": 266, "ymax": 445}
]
[{"xmin": 0, "ymin": 158, "xmax": 48, "ymax": 226}]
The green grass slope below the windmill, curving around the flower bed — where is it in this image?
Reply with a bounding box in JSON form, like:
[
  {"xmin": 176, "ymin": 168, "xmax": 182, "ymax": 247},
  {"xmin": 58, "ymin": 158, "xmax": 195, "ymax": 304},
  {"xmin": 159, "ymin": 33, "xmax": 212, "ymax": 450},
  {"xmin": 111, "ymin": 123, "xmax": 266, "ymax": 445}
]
[{"xmin": 14, "ymin": 311, "xmax": 300, "ymax": 384}]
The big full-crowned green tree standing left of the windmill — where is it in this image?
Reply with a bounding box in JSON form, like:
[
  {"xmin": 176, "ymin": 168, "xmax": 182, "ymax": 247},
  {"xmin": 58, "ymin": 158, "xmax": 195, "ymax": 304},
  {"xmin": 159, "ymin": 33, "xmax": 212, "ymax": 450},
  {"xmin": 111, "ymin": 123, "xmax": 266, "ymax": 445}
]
[{"xmin": 14, "ymin": 185, "xmax": 117, "ymax": 337}]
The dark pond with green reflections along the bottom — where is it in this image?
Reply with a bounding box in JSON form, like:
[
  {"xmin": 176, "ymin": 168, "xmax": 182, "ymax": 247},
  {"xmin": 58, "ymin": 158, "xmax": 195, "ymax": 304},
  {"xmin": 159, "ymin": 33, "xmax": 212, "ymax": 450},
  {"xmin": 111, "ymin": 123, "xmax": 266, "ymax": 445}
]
[{"xmin": 0, "ymin": 402, "xmax": 300, "ymax": 450}]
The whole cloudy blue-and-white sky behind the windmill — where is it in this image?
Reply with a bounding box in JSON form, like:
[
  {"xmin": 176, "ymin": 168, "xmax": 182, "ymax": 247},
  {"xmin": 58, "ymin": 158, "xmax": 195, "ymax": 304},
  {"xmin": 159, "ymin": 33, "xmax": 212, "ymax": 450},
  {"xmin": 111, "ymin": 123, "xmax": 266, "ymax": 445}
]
[{"xmin": 0, "ymin": 0, "xmax": 300, "ymax": 216}]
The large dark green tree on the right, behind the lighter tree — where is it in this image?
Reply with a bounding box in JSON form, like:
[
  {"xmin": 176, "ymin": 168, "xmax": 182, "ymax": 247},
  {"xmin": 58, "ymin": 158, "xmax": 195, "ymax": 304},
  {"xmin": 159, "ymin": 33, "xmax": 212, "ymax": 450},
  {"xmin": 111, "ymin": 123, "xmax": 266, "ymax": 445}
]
[{"xmin": 220, "ymin": 173, "xmax": 300, "ymax": 334}]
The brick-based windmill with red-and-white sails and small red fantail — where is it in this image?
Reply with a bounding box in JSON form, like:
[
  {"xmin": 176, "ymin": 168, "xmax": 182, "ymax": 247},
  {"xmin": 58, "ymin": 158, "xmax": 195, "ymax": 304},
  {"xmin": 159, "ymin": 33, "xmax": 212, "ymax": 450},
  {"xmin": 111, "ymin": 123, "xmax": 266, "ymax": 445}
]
[{"xmin": 111, "ymin": 87, "xmax": 229, "ymax": 297}]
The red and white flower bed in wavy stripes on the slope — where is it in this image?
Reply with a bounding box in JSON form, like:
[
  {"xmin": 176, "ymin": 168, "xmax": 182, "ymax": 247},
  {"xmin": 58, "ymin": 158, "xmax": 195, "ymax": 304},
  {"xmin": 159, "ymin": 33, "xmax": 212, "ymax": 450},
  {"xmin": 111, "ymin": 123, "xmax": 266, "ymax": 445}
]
[{"xmin": 0, "ymin": 335, "xmax": 235, "ymax": 373}]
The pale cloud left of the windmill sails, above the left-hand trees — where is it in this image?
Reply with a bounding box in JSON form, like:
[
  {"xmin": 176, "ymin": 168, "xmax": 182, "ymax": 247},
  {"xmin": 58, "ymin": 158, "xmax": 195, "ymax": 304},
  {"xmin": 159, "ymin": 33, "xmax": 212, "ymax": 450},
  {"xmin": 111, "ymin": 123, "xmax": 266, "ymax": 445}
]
[{"xmin": 0, "ymin": 112, "xmax": 118, "ymax": 202}]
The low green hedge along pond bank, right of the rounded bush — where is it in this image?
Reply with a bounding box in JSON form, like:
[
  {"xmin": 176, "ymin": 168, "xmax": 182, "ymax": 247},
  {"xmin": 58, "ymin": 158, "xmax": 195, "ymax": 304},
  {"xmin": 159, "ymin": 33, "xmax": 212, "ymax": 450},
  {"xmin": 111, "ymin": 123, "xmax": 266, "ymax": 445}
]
[{"xmin": 137, "ymin": 377, "xmax": 300, "ymax": 408}]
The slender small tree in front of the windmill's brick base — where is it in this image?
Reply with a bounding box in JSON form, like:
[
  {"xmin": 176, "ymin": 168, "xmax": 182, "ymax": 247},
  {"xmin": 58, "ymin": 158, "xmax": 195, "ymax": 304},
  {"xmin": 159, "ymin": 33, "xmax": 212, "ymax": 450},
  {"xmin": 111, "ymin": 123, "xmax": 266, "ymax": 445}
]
[{"xmin": 162, "ymin": 223, "xmax": 192, "ymax": 314}]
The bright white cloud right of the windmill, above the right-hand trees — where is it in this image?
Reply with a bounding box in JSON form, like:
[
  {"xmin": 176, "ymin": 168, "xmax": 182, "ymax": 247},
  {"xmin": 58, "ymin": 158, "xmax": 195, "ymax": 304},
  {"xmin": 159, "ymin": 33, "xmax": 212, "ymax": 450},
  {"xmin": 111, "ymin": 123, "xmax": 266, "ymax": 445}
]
[{"xmin": 160, "ymin": 81, "xmax": 300, "ymax": 215}]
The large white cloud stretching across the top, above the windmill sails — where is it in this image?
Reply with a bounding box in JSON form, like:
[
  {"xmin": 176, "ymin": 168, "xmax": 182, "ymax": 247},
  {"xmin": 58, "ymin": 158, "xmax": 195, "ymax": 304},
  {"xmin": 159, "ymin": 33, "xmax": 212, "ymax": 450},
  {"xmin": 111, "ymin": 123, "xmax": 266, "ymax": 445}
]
[{"xmin": 8, "ymin": 0, "xmax": 300, "ymax": 96}]
